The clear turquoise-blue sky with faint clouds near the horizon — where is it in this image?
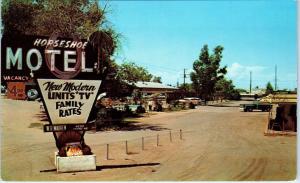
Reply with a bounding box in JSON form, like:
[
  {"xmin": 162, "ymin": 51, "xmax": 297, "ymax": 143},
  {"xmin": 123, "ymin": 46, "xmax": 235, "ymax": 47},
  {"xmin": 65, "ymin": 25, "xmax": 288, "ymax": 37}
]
[{"xmin": 107, "ymin": 0, "xmax": 297, "ymax": 89}]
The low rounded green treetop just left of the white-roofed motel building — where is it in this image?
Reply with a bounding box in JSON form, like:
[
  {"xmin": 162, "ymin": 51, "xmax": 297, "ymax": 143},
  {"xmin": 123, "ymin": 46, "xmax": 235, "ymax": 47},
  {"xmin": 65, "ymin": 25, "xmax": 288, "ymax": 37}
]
[{"xmin": 118, "ymin": 62, "xmax": 152, "ymax": 82}]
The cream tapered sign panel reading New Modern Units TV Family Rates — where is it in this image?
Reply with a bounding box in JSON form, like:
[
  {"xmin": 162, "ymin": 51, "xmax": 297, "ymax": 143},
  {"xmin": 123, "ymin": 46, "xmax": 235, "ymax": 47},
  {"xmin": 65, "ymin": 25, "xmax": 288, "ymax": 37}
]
[{"xmin": 37, "ymin": 79, "xmax": 101, "ymax": 124}]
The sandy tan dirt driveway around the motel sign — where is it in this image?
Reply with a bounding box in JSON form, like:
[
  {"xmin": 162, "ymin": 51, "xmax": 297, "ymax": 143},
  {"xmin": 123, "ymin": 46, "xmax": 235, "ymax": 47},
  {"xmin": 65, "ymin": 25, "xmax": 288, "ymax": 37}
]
[{"xmin": 0, "ymin": 99, "xmax": 296, "ymax": 181}]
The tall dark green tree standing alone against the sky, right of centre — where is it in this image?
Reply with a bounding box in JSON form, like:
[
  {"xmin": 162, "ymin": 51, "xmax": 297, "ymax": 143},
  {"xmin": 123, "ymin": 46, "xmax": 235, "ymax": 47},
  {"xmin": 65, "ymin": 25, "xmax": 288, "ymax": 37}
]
[{"xmin": 190, "ymin": 45, "xmax": 227, "ymax": 101}]
